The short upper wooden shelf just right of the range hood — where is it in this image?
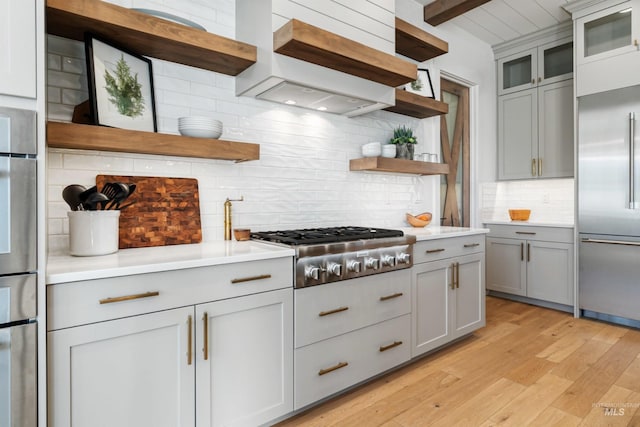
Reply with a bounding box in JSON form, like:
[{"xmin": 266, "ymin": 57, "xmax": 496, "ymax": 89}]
[{"xmin": 396, "ymin": 18, "xmax": 449, "ymax": 62}]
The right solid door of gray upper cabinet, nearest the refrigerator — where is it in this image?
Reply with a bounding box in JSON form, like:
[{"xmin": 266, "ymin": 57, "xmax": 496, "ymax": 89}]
[{"xmin": 538, "ymin": 80, "xmax": 574, "ymax": 178}]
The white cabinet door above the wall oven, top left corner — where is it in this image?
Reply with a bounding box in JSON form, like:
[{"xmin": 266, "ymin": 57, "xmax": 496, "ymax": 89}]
[{"xmin": 0, "ymin": 0, "xmax": 36, "ymax": 98}]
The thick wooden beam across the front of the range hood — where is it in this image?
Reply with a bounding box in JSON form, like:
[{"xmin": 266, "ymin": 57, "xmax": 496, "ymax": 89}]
[{"xmin": 273, "ymin": 19, "xmax": 418, "ymax": 87}]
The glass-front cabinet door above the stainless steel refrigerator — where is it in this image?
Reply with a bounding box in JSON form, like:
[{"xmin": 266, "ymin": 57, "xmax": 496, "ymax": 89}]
[{"xmin": 576, "ymin": 1, "xmax": 640, "ymax": 63}]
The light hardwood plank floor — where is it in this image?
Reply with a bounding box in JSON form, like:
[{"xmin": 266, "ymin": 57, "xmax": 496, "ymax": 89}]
[{"xmin": 278, "ymin": 297, "xmax": 640, "ymax": 427}]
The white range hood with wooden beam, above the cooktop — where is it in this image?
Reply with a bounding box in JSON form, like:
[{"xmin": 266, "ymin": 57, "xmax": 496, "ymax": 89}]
[{"xmin": 236, "ymin": 0, "xmax": 417, "ymax": 116}]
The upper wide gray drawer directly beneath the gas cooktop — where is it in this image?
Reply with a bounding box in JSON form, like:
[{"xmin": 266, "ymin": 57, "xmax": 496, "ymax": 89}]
[{"xmin": 294, "ymin": 269, "xmax": 411, "ymax": 348}]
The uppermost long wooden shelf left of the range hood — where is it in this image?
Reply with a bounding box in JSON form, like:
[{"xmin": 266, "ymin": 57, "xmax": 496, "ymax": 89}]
[{"xmin": 47, "ymin": 0, "xmax": 257, "ymax": 76}]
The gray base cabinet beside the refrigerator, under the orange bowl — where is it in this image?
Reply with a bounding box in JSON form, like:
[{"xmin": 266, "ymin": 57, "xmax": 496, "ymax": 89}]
[{"xmin": 487, "ymin": 224, "xmax": 574, "ymax": 306}]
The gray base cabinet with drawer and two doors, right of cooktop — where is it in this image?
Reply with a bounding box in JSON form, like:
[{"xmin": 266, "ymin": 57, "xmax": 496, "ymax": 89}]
[{"xmin": 412, "ymin": 234, "xmax": 485, "ymax": 357}]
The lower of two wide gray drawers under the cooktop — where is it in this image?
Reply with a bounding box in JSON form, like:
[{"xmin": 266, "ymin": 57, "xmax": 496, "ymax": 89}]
[{"xmin": 294, "ymin": 314, "xmax": 411, "ymax": 410}]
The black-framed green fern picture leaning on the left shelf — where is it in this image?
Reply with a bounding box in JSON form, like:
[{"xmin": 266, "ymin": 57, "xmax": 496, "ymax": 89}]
[{"xmin": 85, "ymin": 33, "xmax": 158, "ymax": 132}]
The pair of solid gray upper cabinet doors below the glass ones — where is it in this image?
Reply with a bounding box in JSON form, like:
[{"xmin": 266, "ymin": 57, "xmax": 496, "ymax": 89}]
[{"xmin": 498, "ymin": 80, "xmax": 573, "ymax": 179}]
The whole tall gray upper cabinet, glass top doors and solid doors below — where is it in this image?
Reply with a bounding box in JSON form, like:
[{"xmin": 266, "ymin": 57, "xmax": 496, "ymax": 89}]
[{"xmin": 494, "ymin": 25, "xmax": 574, "ymax": 180}]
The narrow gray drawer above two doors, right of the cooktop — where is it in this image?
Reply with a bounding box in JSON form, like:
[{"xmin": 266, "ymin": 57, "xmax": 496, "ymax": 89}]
[{"xmin": 413, "ymin": 234, "xmax": 485, "ymax": 264}]
